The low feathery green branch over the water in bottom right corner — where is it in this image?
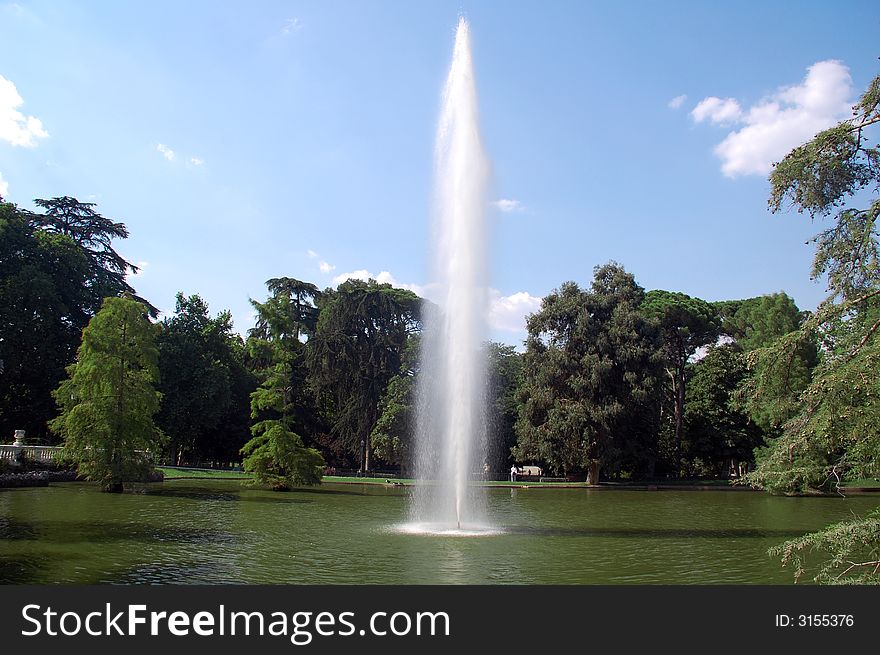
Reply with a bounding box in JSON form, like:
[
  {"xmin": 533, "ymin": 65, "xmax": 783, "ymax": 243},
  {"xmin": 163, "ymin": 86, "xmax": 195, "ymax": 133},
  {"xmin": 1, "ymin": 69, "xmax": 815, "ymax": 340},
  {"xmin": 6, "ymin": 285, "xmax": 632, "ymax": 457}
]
[{"xmin": 770, "ymin": 509, "xmax": 880, "ymax": 584}]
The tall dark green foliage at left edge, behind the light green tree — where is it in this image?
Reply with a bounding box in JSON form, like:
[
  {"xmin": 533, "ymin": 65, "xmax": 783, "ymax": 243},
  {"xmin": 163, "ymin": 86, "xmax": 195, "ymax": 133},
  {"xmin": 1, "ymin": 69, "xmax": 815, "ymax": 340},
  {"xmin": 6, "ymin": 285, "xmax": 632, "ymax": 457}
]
[{"xmin": 0, "ymin": 198, "xmax": 148, "ymax": 442}]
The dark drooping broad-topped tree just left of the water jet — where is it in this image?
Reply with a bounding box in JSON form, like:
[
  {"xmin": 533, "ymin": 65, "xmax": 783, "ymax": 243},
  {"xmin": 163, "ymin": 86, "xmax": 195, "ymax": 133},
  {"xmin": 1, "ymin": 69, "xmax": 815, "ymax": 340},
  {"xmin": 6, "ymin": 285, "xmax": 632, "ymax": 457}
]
[{"xmin": 308, "ymin": 280, "xmax": 421, "ymax": 472}]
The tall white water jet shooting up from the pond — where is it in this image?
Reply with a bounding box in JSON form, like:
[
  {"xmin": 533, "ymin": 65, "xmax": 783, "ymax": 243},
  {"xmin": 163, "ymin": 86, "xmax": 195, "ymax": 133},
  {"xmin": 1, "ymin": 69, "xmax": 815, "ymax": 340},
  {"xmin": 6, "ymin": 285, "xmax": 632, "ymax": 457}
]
[{"xmin": 411, "ymin": 18, "xmax": 489, "ymax": 531}]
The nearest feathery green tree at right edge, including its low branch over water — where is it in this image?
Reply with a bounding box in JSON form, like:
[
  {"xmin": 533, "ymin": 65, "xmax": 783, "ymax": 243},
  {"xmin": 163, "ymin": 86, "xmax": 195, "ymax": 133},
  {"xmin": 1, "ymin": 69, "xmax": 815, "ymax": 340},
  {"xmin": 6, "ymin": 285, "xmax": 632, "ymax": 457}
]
[{"xmin": 748, "ymin": 76, "xmax": 880, "ymax": 583}]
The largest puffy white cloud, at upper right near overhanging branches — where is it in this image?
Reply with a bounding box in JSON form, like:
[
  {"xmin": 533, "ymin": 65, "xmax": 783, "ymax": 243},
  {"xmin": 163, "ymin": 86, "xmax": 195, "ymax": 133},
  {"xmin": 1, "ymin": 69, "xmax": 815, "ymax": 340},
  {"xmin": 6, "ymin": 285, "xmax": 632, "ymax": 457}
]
[{"xmin": 691, "ymin": 60, "xmax": 852, "ymax": 177}]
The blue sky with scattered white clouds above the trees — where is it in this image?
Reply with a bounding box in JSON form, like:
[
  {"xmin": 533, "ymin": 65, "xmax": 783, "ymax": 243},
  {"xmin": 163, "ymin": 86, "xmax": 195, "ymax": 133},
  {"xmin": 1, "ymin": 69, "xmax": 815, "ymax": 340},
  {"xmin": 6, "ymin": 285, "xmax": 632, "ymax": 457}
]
[{"xmin": 0, "ymin": 0, "xmax": 880, "ymax": 344}]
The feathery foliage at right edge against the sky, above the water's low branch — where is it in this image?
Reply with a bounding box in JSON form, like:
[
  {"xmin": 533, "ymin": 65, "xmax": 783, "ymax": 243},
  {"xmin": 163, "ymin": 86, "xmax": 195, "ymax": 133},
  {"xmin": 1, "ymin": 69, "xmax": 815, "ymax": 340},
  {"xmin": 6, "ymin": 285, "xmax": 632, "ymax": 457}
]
[{"xmin": 750, "ymin": 70, "xmax": 880, "ymax": 492}]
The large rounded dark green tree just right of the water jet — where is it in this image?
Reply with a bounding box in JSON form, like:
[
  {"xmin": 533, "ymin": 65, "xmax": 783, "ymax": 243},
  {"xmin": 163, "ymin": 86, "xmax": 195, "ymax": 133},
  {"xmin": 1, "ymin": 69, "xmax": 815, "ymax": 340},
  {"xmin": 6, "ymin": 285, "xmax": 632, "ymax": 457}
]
[{"xmin": 515, "ymin": 262, "xmax": 657, "ymax": 484}]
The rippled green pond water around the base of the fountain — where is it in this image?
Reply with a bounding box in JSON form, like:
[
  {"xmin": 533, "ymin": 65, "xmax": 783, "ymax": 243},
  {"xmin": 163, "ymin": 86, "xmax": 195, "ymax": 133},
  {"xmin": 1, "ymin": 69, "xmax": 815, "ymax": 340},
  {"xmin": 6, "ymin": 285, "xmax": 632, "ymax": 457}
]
[{"xmin": 0, "ymin": 480, "xmax": 877, "ymax": 584}]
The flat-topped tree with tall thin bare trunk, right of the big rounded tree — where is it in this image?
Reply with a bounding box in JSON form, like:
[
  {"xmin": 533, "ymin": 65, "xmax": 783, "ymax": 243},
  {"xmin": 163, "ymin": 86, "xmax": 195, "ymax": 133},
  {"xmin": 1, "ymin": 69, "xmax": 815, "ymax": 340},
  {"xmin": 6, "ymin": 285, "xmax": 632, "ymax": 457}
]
[{"xmin": 643, "ymin": 290, "xmax": 718, "ymax": 475}]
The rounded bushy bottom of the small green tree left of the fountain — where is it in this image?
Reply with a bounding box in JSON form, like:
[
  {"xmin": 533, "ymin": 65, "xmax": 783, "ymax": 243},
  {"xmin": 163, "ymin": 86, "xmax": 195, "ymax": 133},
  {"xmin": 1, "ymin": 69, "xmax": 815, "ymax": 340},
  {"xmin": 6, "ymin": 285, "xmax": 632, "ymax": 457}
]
[{"xmin": 241, "ymin": 420, "xmax": 325, "ymax": 491}]
